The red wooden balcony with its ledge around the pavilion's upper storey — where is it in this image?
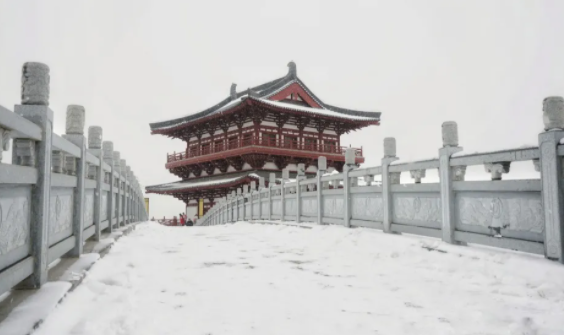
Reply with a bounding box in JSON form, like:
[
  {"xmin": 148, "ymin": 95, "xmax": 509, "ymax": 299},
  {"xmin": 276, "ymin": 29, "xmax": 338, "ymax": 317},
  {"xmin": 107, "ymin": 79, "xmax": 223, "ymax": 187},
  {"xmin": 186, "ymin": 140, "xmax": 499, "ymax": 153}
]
[{"xmin": 166, "ymin": 137, "xmax": 364, "ymax": 168}]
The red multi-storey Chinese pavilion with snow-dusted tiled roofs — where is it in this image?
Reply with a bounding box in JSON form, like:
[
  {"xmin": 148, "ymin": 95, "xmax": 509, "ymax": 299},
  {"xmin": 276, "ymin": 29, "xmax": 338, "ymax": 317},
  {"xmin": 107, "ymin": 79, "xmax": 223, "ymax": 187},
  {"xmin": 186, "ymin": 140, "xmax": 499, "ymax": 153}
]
[{"xmin": 147, "ymin": 62, "xmax": 380, "ymax": 217}]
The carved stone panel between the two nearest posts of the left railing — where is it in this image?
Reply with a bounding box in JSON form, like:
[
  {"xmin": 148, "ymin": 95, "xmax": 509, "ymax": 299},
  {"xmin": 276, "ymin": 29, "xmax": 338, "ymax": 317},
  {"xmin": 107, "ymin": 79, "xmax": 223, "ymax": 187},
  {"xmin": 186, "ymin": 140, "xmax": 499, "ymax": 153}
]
[{"xmin": 49, "ymin": 188, "xmax": 73, "ymax": 245}]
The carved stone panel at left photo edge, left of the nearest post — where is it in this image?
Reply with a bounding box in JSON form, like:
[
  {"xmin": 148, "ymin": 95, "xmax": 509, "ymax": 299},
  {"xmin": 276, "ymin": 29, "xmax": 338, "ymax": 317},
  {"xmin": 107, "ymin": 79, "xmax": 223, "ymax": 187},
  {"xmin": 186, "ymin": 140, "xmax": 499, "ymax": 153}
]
[{"xmin": 0, "ymin": 187, "xmax": 31, "ymax": 258}]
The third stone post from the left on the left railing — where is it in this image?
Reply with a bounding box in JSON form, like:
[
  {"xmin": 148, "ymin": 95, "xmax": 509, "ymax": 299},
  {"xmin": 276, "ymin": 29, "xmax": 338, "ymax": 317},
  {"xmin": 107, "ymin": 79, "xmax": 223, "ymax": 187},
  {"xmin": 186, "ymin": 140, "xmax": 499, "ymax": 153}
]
[{"xmin": 88, "ymin": 126, "xmax": 104, "ymax": 241}]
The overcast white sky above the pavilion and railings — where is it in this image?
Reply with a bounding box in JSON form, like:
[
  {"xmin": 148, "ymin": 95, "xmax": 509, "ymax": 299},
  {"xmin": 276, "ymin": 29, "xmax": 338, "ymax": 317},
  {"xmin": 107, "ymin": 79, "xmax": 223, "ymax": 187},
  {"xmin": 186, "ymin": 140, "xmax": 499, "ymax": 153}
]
[{"xmin": 0, "ymin": 0, "xmax": 564, "ymax": 217}]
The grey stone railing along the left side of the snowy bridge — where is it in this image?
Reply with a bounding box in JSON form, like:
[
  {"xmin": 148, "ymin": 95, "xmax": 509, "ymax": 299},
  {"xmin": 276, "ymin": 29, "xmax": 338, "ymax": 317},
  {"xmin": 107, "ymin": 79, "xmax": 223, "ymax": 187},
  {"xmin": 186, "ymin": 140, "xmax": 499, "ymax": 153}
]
[{"xmin": 0, "ymin": 63, "xmax": 147, "ymax": 294}]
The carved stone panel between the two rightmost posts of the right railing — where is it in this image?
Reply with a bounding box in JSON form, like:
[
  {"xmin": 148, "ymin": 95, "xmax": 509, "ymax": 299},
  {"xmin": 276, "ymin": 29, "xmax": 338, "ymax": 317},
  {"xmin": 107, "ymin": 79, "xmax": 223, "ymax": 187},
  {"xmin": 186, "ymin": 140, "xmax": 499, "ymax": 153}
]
[{"xmin": 456, "ymin": 192, "xmax": 544, "ymax": 241}]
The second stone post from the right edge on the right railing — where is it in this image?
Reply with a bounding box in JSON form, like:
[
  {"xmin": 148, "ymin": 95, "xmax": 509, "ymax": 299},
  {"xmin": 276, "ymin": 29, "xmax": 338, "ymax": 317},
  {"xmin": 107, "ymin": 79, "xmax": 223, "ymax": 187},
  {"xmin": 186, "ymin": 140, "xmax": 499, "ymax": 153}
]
[{"xmin": 439, "ymin": 121, "xmax": 462, "ymax": 243}]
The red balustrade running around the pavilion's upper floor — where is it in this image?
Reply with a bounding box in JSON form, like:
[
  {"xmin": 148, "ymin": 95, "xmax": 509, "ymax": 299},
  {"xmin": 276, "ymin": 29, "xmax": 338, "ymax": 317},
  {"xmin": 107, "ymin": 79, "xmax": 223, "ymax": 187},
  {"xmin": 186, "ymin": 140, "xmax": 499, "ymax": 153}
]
[{"xmin": 167, "ymin": 137, "xmax": 362, "ymax": 163}]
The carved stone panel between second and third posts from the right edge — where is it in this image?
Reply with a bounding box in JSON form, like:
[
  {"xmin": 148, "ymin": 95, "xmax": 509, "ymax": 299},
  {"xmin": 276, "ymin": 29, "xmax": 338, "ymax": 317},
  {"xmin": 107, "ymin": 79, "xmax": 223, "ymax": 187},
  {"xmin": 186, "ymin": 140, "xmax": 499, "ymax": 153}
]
[{"xmin": 392, "ymin": 193, "xmax": 442, "ymax": 228}]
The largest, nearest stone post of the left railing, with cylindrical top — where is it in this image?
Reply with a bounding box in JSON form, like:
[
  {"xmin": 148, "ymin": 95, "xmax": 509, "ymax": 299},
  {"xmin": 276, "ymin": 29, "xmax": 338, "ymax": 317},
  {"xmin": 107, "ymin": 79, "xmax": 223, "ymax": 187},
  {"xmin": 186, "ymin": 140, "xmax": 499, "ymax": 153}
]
[{"xmin": 13, "ymin": 63, "xmax": 53, "ymax": 288}]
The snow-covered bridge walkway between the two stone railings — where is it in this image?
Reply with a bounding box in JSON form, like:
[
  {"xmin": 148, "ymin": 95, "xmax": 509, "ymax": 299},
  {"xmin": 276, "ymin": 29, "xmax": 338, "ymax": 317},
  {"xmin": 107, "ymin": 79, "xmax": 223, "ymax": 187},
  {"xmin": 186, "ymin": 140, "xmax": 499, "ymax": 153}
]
[{"xmin": 34, "ymin": 223, "xmax": 564, "ymax": 335}]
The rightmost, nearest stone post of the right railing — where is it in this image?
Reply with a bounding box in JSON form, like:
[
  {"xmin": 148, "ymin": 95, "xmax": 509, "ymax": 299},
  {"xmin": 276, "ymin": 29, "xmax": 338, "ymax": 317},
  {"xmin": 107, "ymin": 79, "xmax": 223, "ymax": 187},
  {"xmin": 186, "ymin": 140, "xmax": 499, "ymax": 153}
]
[{"xmin": 539, "ymin": 97, "xmax": 564, "ymax": 263}]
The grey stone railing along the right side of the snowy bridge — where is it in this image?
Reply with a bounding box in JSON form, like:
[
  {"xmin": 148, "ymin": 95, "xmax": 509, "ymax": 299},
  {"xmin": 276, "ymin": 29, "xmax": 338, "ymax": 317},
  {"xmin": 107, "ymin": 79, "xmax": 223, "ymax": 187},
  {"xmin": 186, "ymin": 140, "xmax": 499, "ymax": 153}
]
[{"xmin": 197, "ymin": 97, "xmax": 564, "ymax": 263}]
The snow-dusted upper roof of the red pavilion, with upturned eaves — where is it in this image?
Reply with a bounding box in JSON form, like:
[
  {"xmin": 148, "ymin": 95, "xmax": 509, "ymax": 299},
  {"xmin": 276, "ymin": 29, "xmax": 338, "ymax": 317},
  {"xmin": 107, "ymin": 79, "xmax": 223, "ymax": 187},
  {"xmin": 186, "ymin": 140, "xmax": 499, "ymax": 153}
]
[{"xmin": 150, "ymin": 62, "xmax": 381, "ymax": 131}]
